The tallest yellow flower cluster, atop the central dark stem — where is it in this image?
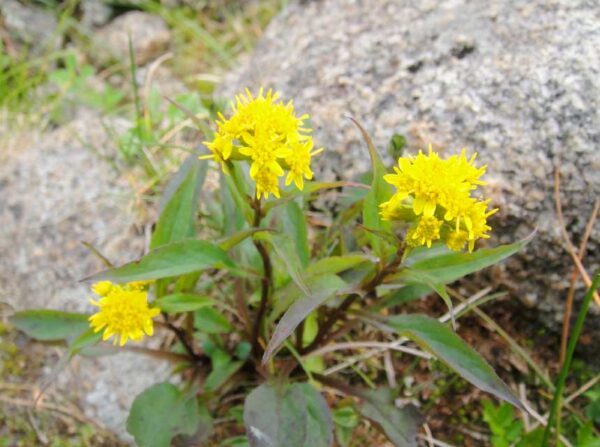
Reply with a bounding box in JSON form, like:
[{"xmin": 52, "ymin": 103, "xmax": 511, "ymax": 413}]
[{"xmin": 201, "ymin": 88, "xmax": 322, "ymax": 199}]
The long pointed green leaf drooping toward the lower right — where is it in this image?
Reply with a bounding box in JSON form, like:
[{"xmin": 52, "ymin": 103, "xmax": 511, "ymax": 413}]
[{"xmin": 383, "ymin": 315, "xmax": 523, "ymax": 409}]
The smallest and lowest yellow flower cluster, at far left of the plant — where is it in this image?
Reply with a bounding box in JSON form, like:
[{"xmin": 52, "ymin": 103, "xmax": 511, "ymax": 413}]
[{"xmin": 89, "ymin": 281, "xmax": 160, "ymax": 346}]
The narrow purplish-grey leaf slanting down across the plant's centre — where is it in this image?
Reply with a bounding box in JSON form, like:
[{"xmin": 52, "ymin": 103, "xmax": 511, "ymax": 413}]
[{"xmin": 262, "ymin": 275, "xmax": 346, "ymax": 363}]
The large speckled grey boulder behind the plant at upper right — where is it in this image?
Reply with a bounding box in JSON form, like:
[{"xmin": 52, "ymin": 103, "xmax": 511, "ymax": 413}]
[{"xmin": 220, "ymin": 0, "xmax": 600, "ymax": 352}]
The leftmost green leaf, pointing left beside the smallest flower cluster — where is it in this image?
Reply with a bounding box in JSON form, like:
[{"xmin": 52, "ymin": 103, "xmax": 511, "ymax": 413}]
[{"xmin": 10, "ymin": 309, "xmax": 90, "ymax": 341}]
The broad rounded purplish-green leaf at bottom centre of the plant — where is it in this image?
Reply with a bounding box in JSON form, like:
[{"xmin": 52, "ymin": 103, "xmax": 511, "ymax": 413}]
[{"xmin": 244, "ymin": 383, "xmax": 333, "ymax": 447}]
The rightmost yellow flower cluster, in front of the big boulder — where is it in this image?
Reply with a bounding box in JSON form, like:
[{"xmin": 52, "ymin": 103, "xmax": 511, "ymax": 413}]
[{"xmin": 380, "ymin": 147, "xmax": 498, "ymax": 251}]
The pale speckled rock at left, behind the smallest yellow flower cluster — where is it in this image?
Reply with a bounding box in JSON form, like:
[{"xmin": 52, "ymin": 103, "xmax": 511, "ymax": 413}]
[{"xmin": 0, "ymin": 111, "xmax": 170, "ymax": 439}]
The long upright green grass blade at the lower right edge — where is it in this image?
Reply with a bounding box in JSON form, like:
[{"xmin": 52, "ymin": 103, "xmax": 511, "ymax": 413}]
[{"xmin": 541, "ymin": 272, "xmax": 600, "ymax": 447}]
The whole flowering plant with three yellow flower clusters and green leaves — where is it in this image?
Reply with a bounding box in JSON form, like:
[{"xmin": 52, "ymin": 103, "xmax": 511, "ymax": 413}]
[{"xmin": 13, "ymin": 90, "xmax": 526, "ymax": 447}]
